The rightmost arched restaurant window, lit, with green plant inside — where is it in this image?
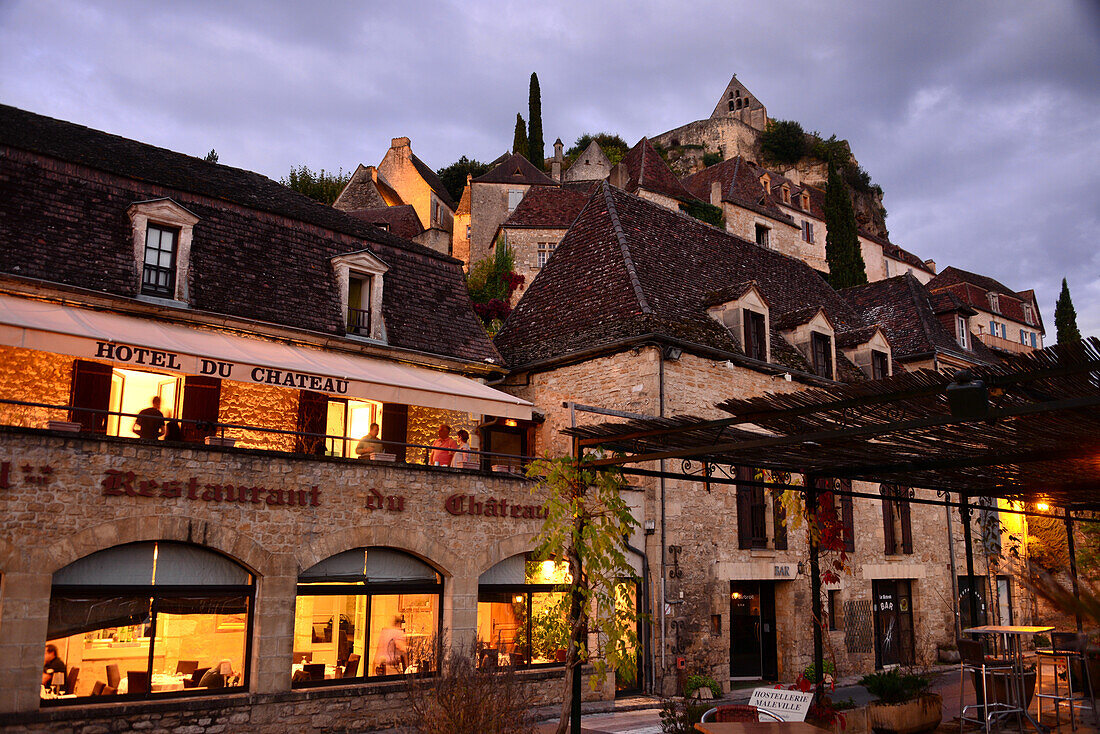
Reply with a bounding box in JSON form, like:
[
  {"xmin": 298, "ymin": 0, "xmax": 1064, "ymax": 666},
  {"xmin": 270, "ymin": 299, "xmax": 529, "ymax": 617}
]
[{"xmin": 477, "ymin": 554, "xmax": 570, "ymax": 667}]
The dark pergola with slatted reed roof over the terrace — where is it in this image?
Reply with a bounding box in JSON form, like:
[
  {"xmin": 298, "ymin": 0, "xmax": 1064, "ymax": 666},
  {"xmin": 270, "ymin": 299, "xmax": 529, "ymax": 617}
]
[{"xmin": 567, "ymin": 338, "xmax": 1100, "ymax": 704}]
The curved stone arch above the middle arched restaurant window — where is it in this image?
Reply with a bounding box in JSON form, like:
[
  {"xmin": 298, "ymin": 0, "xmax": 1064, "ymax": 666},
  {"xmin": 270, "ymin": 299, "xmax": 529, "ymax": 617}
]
[{"xmin": 294, "ymin": 525, "xmax": 469, "ymax": 578}]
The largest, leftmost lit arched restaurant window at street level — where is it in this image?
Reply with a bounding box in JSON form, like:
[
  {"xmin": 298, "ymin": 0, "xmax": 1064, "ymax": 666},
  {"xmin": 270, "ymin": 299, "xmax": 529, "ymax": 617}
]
[{"xmin": 42, "ymin": 541, "xmax": 255, "ymax": 703}]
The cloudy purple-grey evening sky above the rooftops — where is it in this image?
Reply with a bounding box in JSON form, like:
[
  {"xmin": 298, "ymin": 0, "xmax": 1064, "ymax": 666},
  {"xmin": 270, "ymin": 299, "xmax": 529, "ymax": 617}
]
[{"xmin": 0, "ymin": 0, "xmax": 1100, "ymax": 342}]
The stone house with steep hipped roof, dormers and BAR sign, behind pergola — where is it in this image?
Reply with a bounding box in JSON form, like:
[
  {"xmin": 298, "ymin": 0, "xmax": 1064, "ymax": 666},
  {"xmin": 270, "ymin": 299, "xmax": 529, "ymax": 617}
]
[{"xmin": 494, "ymin": 183, "xmax": 976, "ymax": 692}]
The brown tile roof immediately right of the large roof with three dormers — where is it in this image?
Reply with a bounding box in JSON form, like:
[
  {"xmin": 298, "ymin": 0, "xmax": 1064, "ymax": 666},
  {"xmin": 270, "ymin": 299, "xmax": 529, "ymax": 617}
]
[{"xmin": 840, "ymin": 273, "xmax": 998, "ymax": 363}]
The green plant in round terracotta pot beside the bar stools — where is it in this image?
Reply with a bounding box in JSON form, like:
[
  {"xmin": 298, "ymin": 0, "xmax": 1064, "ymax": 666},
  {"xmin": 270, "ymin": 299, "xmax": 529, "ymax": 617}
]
[{"xmin": 859, "ymin": 669, "xmax": 943, "ymax": 734}]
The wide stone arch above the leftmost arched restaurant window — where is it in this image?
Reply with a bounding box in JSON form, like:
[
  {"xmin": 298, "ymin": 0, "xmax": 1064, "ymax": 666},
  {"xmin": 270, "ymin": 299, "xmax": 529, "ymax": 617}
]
[{"xmin": 31, "ymin": 515, "xmax": 281, "ymax": 577}]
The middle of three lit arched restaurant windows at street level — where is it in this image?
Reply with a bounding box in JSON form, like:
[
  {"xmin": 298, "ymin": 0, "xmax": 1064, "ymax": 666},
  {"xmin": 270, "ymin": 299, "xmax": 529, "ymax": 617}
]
[{"xmin": 290, "ymin": 547, "xmax": 443, "ymax": 687}]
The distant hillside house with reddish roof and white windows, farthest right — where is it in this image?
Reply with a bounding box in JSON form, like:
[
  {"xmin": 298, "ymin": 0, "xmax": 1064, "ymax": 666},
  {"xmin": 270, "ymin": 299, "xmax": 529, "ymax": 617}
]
[{"xmin": 928, "ymin": 267, "xmax": 1046, "ymax": 354}]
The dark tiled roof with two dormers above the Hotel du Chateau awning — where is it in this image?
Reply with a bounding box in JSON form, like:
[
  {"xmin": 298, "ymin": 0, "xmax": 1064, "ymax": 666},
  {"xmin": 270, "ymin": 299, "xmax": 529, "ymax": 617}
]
[{"xmin": 0, "ymin": 106, "xmax": 499, "ymax": 362}]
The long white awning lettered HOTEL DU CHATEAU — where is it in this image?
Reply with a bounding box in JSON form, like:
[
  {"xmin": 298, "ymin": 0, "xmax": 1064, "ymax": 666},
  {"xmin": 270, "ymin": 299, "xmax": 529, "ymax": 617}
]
[{"xmin": 0, "ymin": 295, "xmax": 531, "ymax": 420}]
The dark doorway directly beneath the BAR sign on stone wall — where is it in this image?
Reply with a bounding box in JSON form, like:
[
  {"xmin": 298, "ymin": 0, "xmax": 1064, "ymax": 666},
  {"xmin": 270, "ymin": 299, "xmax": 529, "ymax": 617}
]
[{"xmin": 729, "ymin": 581, "xmax": 779, "ymax": 680}]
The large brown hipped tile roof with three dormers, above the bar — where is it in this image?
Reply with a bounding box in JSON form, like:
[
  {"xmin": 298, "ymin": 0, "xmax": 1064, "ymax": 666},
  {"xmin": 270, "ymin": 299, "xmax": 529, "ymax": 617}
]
[{"xmin": 495, "ymin": 183, "xmax": 865, "ymax": 379}]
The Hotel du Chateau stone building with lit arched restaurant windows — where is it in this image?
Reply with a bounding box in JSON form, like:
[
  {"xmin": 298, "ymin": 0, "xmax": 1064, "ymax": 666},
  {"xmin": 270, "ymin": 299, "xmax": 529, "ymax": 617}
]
[{"xmin": 0, "ymin": 107, "xmax": 629, "ymax": 734}]
